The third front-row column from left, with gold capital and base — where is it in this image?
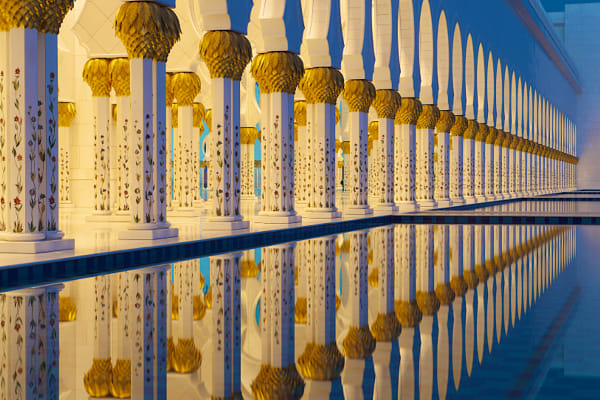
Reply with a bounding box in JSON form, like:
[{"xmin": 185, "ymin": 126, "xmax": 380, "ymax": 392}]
[{"xmin": 200, "ymin": 31, "xmax": 251, "ymax": 231}]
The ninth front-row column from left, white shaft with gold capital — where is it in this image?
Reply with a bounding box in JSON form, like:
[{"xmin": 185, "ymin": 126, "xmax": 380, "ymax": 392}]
[{"xmin": 416, "ymin": 105, "xmax": 440, "ymax": 209}]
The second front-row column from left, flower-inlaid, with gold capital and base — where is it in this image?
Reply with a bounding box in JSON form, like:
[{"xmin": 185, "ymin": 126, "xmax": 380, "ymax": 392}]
[{"xmin": 115, "ymin": 2, "xmax": 179, "ymax": 240}]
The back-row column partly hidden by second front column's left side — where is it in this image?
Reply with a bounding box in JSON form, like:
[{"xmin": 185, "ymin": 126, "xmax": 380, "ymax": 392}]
[{"xmin": 108, "ymin": 58, "xmax": 131, "ymax": 215}]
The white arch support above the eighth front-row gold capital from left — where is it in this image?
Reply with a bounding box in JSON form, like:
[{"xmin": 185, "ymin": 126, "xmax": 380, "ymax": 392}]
[{"xmin": 398, "ymin": 0, "xmax": 415, "ymax": 97}]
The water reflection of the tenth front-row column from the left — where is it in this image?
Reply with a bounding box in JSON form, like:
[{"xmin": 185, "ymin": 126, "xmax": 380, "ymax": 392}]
[{"xmin": 433, "ymin": 225, "xmax": 456, "ymax": 399}]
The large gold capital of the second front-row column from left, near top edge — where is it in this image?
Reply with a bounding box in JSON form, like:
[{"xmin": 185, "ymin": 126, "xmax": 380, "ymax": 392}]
[{"xmin": 115, "ymin": 1, "xmax": 181, "ymax": 62}]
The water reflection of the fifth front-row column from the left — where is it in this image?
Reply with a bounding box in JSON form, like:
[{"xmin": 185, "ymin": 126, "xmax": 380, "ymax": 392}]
[{"xmin": 297, "ymin": 236, "xmax": 344, "ymax": 399}]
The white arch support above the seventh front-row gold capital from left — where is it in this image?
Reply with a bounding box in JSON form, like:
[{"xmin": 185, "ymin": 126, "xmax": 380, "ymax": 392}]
[{"xmin": 372, "ymin": 0, "xmax": 393, "ymax": 89}]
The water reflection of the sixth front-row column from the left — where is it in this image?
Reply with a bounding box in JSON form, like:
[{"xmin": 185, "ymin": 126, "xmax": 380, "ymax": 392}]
[{"xmin": 342, "ymin": 231, "xmax": 375, "ymax": 400}]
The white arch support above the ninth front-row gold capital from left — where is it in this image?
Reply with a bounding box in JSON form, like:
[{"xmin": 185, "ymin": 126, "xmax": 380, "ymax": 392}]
[{"xmin": 419, "ymin": 0, "xmax": 434, "ymax": 104}]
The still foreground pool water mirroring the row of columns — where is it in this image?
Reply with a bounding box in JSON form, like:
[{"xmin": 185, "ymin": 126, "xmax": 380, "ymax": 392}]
[{"xmin": 0, "ymin": 224, "xmax": 600, "ymax": 399}]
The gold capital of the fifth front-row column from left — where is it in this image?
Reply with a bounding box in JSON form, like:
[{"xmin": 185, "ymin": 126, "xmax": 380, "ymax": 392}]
[{"xmin": 299, "ymin": 67, "xmax": 344, "ymax": 105}]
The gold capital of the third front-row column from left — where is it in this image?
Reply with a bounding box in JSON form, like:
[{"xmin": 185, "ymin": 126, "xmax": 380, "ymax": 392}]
[{"xmin": 199, "ymin": 31, "xmax": 252, "ymax": 81}]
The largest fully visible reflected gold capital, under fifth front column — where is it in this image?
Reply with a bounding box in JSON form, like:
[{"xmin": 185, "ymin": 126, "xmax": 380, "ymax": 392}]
[{"xmin": 298, "ymin": 341, "xmax": 345, "ymax": 381}]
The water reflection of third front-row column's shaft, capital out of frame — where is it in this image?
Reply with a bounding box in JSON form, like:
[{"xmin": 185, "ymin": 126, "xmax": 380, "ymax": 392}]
[{"xmin": 210, "ymin": 253, "xmax": 242, "ymax": 398}]
